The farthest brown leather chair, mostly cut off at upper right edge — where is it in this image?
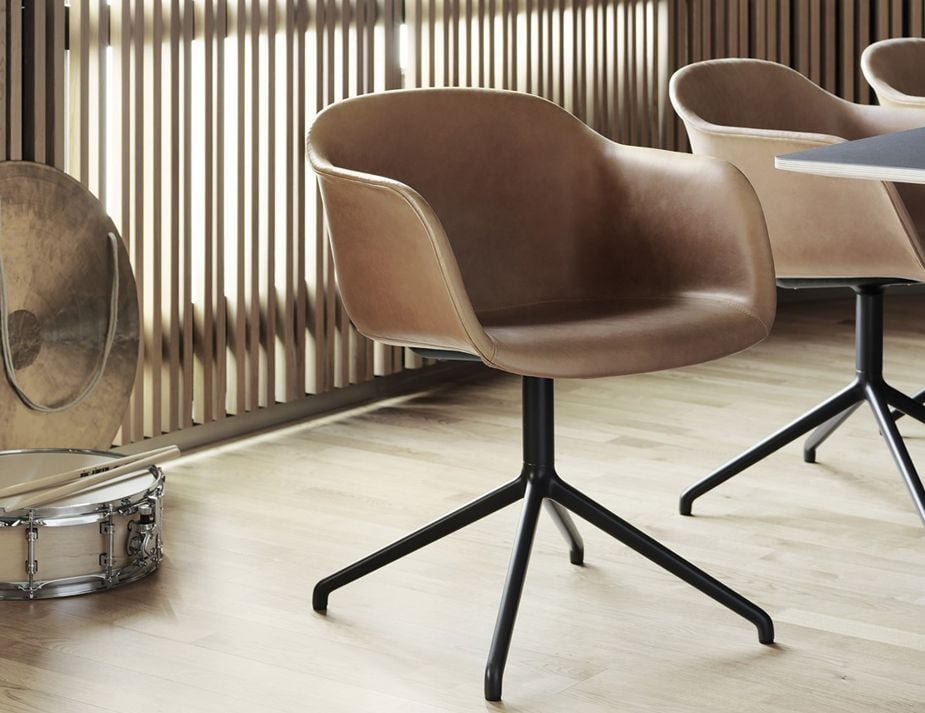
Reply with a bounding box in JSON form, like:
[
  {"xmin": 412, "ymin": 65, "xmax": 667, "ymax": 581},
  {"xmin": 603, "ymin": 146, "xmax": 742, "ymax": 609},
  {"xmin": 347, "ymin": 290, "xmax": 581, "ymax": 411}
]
[{"xmin": 861, "ymin": 37, "xmax": 925, "ymax": 113}]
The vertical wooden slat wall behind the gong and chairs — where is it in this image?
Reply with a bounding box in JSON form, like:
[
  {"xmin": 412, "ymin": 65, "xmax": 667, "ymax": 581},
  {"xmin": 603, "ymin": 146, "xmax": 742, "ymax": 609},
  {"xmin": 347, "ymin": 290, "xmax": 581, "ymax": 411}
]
[{"xmin": 0, "ymin": 0, "xmax": 925, "ymax": 442}]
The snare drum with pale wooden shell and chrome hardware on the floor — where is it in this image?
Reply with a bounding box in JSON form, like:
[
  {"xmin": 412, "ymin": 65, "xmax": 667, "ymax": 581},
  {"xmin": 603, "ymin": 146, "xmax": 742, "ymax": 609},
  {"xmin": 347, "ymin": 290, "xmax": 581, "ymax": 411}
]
[{"xmin": 0, "ymin": 449, "xmax": 164, "ymax": 599}]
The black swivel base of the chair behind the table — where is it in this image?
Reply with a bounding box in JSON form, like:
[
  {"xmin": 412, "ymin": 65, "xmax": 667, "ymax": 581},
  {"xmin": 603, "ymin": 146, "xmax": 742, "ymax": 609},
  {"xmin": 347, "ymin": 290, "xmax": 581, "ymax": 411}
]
[{"xmin": 680, "ymin": 284, "xmax": 925, "ymax": 522}]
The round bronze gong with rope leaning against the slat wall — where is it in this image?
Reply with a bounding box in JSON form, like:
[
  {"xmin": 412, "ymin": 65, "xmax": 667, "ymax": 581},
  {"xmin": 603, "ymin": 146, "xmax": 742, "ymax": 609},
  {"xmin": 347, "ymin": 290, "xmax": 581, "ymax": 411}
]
[{"xmin": 0, "ymin": 161, "xmax": 138, "ymax": 449}]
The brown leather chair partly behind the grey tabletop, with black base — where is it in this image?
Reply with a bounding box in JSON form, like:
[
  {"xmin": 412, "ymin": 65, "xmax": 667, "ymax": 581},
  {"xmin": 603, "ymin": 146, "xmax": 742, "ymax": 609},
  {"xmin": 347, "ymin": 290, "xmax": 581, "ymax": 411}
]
[{"xmin": 669, "ymin": 59, "xmax": 925, "ymax": 520}]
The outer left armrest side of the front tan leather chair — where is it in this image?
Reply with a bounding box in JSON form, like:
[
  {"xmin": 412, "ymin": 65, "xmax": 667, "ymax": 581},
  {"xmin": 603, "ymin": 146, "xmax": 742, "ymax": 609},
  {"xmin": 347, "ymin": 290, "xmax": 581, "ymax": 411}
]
[{"xmin": 310, "ymin": 163, "xmax": 491, "ymax": 359}]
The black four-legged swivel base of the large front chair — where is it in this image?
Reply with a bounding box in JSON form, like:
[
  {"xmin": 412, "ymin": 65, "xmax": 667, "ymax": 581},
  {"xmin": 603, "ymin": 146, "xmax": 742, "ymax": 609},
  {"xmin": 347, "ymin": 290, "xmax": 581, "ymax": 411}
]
[{"xmin": 312, "ymin": 377, "xmax": 774, "ymax": 701}]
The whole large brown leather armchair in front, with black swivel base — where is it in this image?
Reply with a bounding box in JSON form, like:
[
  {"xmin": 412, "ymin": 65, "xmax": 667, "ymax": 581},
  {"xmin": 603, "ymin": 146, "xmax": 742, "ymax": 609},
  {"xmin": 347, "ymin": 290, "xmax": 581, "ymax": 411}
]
[{"xmin": 308, "ymin": 89, "xmax": 775, "ymax": 700}]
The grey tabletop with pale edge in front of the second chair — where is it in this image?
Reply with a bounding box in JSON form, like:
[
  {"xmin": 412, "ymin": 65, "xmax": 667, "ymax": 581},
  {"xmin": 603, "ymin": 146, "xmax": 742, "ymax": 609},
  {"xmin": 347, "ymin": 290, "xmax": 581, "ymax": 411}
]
[{"xmin": 774, "ymin": 127, "xmax": 925, "ymax": 183}]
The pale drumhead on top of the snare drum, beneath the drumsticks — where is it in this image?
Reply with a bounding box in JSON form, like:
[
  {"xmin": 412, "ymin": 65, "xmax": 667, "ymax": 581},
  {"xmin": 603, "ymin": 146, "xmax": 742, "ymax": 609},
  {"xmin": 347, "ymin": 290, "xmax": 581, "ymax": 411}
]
[{"xmin": 0, "ymin": 448, "xmax": 162, "ymax": 520}]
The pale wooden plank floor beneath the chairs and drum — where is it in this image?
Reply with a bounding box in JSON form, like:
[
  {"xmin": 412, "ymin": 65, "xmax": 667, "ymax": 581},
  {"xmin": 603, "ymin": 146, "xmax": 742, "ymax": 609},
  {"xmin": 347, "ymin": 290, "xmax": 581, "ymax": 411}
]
[{"xmin": 0, "ymin": 296, "xmax": 925, "ymax": 713}]
